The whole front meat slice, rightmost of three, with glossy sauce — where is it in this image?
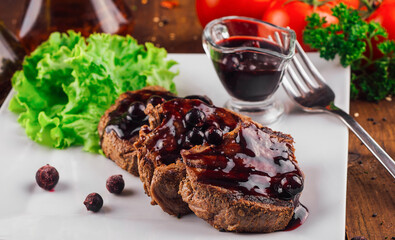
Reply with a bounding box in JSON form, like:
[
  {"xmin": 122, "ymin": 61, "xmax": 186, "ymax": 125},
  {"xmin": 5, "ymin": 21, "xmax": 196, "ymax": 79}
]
[{"xmin": 179, "ymin": 121, "xmax": 304, "ymax": 232}]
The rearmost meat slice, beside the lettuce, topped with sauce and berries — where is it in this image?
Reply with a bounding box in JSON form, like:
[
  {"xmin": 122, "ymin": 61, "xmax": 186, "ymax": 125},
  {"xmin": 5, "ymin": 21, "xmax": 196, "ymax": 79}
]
[{"xmin": 98, "ymin": 86, "xmax": 175, "ymax": 176}]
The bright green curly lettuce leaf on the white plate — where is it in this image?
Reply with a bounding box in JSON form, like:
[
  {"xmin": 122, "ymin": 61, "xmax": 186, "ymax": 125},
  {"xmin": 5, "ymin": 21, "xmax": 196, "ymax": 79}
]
[{"xmin": 9, "ymin": 31, "xmax": 177, "ymax": 153}]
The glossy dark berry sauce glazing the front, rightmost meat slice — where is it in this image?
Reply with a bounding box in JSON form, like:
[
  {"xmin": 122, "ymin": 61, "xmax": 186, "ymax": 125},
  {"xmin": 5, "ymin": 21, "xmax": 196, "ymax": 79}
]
[{"xmin": 182, "ymin": 123, "xmax": 303, "ymax": 200}]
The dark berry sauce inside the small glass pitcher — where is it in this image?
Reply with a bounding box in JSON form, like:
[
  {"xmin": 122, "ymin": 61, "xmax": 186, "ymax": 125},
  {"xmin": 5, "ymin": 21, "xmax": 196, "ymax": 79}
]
[{"xmin": 213, "ymin": 37, "xmax": 283, "ymax": 101}]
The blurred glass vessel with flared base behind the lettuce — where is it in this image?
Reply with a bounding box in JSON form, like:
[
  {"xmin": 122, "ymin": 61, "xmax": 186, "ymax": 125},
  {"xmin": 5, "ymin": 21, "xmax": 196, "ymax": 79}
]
[{"xmin": 18, "ymin": 0, "xmax": 133, "ymax": 52}]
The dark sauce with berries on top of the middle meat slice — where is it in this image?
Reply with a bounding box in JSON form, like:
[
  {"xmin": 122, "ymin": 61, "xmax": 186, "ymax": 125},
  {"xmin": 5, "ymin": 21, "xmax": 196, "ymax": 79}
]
[{"xmin": 142, "ymin": 99, "xmax": 240, "ymax": 166}]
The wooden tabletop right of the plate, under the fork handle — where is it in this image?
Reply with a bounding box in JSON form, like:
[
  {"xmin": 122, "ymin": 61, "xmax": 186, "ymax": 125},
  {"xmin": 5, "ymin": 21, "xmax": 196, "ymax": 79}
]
[{"xmin": 346, "ymin": 100, "xmax": 395, "ymax": 240}]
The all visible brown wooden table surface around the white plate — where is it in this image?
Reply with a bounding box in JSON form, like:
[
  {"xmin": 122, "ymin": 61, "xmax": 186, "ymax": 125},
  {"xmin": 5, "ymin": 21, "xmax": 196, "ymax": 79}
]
[{"xmin": 0, "ymin": 0, "xmax": 395, "ymax": 240}]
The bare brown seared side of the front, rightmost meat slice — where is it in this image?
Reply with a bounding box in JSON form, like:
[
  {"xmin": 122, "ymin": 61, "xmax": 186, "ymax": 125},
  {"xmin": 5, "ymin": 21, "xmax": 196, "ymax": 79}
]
[{"xmin": 180, "ymin": 177, "xmax": 293, "ymax": 232}]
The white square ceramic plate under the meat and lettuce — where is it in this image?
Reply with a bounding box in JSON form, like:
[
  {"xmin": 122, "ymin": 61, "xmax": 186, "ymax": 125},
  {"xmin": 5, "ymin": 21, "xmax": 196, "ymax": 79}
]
[{"xmin": 0, "ymin": 54, "xmax": 349, "ymax": 240}]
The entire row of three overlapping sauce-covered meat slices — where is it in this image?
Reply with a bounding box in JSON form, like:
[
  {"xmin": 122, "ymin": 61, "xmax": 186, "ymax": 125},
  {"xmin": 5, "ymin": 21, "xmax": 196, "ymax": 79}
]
[{"xmin": 98, "ymin": 87, "xmax": 307, "ymax": 232}]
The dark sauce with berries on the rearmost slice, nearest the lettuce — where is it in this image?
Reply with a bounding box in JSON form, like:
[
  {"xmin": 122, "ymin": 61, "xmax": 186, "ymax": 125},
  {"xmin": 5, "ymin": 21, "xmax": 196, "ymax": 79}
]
[{"xmin": 105, "ymin": 90, "xmax": 175, "ymax": 139}]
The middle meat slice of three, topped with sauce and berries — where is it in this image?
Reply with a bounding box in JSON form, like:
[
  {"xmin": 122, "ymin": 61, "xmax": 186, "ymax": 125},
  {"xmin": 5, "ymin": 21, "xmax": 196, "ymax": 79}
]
[{"xmin": 135, "ymin": 99, "xmax": 240, "ymax": 216}]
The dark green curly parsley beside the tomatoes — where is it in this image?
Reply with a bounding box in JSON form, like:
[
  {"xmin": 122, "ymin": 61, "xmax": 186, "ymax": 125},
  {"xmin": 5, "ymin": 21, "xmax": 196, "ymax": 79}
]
[{"xmin": 303, "ymin": 3, "xmax": 395, "ymax": 101}]
